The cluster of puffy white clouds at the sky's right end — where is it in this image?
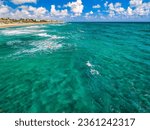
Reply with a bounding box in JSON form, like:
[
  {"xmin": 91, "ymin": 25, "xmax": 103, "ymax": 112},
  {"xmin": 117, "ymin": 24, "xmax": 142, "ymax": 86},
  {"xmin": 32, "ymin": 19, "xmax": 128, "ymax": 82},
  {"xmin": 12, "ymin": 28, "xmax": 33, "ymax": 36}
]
[{"xmin": 106, "ymin": 0, "xmax": 150, "ymax": 18}]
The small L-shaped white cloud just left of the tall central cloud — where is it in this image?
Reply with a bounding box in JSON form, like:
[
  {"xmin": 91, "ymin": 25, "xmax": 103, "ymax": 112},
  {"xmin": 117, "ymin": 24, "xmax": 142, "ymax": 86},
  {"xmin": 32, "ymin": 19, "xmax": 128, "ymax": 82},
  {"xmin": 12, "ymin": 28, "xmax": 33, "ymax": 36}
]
[{"xmin": 50, "ymin": 5, "xmax": 68, "ymax": 17}]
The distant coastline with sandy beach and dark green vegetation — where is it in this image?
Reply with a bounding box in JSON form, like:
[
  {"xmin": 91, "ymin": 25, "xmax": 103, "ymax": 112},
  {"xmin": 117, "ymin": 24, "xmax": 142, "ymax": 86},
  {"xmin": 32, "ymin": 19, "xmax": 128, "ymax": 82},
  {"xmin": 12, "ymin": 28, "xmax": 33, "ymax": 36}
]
[{"xmin": 0, "ymin": 18, "xmax": 64, "ymax": 28}]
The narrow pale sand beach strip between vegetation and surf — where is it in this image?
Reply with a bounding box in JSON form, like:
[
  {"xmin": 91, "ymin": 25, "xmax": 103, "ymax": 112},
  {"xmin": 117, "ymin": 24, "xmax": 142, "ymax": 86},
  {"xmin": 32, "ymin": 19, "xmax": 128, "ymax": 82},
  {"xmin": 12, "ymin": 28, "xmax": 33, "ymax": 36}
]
[{"xmin": 0, "ymin": 22, "xmax": 63, "ymax": 29}]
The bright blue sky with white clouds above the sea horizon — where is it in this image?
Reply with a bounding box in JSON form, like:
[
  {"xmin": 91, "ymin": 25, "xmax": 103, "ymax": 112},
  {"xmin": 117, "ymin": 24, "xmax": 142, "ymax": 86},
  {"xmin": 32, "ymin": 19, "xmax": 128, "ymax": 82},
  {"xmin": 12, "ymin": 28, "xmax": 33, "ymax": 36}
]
[{"xmin": 0, "ymin": 0, "xmax": 150, "ymax": 21}]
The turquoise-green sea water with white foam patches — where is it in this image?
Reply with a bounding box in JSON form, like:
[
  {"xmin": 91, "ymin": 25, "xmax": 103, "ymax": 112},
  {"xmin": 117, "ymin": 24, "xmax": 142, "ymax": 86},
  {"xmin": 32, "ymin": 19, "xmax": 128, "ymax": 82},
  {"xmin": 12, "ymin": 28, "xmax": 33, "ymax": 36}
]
[{"xmin": 0, "ymin": 23, "xmax": 150, "ymax": 113}]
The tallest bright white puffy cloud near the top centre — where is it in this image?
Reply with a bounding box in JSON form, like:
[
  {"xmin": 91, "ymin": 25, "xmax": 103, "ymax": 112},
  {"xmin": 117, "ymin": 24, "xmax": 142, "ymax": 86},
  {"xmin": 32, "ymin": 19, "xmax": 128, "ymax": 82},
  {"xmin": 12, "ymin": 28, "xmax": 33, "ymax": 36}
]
[{"xmin": 65, "ymin": 0, "xmax": 84, "ymax": 16}]
